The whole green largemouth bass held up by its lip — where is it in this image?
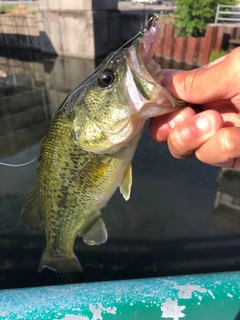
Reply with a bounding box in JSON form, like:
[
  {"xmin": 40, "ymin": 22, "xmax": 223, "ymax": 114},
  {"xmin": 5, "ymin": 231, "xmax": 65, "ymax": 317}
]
[{"xmin": 22, "ymin": 16, "xmax": 185, "ymax": 281}]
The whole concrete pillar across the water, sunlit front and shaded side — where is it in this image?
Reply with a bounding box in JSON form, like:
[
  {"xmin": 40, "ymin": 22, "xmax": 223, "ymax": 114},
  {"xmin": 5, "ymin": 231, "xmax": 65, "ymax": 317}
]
[{"xmin": 38, "ymin": 0, "xmax": 120, "ymax": 59}]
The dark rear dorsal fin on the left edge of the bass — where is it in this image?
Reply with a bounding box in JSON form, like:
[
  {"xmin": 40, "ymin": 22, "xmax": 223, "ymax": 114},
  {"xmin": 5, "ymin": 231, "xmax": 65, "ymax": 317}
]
[{"xmin": 21, "ymin": 184, "xmax": 43, "ymax": 232}]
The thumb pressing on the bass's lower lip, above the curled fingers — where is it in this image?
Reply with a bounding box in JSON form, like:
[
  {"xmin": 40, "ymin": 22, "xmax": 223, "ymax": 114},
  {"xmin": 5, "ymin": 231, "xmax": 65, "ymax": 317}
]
[{"xmin": 161, "ymin": 48, "xmax": 240, "ymax": 104}]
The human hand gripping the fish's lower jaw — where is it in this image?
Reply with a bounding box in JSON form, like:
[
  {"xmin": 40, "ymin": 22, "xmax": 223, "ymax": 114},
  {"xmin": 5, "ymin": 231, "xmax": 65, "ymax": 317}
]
[{"xmin": 149, "ymin": 48, "xmax": 240, "ymax": 168}]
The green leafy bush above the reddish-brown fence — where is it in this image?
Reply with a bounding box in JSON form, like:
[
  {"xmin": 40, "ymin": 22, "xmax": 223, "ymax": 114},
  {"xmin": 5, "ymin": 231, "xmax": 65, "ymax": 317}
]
[{"xmin": 174, "ymin": 0, "xmax": 237, "ymax": 37}]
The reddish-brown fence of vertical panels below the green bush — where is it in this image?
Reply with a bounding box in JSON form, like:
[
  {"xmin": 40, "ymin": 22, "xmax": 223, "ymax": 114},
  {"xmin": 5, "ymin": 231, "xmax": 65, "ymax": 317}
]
[{"xmin": 156, "ymin": 24, "xmax": 240, "ymax": 66}]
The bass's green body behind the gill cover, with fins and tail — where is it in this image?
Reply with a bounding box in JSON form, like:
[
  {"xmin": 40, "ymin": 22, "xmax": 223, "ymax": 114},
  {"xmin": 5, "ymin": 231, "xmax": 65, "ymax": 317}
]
[{"xmin": 22, "ymin": 110, "xmax": 141, "ymax": 280}]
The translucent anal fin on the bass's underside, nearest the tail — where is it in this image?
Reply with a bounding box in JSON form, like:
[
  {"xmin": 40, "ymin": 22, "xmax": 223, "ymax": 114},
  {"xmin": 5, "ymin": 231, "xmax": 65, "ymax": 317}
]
[{"xmin": 81, "ymin": 211, "xmax": 108, "ymax": 246}]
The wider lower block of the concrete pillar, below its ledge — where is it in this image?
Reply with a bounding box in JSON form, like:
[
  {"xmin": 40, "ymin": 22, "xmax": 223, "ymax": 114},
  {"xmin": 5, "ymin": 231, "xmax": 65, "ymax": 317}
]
[{"xmin": 38, "ymin": 11, "xmax": 120, "ymax": 59}]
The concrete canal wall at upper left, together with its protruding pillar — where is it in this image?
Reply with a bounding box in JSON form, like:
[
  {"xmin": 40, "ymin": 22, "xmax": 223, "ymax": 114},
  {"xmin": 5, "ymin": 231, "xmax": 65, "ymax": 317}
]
[{"xmin": 0, "ymin": 0, "xmax": 147, "ymax": 59}]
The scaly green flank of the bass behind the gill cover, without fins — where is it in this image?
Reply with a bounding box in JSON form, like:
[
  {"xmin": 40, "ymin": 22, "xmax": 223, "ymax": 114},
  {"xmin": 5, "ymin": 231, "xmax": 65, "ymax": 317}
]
[{"xmin": 23, "ymin": 100, "xmax": 140, "ymax": 280}]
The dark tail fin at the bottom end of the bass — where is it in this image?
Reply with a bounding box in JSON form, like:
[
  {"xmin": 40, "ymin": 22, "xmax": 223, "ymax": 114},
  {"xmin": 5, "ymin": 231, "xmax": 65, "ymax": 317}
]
[{"xmin": 38, "ymin": 249, "xmax": 86, "ymax": 283}]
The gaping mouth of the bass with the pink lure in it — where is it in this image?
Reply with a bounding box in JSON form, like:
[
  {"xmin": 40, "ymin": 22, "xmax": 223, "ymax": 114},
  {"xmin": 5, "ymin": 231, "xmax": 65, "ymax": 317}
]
[{"xmin": 126, "ymin": 14, "xmax": 186, "ymax": 120}]
